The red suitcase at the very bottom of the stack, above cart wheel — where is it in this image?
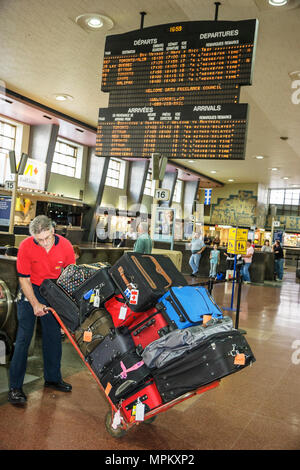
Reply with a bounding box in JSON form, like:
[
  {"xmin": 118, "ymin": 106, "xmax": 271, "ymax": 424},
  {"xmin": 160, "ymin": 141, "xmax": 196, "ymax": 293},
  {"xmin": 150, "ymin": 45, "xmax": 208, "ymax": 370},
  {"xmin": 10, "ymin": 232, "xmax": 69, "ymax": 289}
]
[{"xmin": 121, "ymin": 381, "xmax": 162, "ymax": 423}]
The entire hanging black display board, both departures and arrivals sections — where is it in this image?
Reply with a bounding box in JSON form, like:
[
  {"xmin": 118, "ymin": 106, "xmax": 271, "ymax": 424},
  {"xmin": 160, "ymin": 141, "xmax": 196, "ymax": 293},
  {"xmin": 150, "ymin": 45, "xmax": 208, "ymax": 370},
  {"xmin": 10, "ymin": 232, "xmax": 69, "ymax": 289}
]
[{"xmin": 96, "ymin": 20, "xmax": 258, "ymax": 160}]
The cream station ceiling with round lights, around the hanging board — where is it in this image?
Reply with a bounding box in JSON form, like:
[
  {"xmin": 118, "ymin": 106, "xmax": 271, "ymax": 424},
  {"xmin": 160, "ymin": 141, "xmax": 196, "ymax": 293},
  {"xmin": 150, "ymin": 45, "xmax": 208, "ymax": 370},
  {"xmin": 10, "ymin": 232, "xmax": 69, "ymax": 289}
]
[{"xmin": 0, "ymin": 0, "xmax": 300, "ymax": 188}]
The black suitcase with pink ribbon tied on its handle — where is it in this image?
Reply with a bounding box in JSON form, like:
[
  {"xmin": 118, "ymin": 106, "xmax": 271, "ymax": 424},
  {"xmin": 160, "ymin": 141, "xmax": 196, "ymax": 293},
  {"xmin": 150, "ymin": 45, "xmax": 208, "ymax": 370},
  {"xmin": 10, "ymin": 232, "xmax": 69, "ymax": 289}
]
[{"xmin": 99, "ymin": 350, "xmax": 150, "ymax": 403}]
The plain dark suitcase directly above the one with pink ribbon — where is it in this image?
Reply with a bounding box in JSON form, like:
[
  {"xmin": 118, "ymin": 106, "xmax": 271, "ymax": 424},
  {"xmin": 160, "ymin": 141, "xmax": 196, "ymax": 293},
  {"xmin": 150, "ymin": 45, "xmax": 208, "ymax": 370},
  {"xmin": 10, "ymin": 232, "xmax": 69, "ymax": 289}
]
[{"xmin": 87, "ymin": 326, "xmax": 135, "ymax": 377}]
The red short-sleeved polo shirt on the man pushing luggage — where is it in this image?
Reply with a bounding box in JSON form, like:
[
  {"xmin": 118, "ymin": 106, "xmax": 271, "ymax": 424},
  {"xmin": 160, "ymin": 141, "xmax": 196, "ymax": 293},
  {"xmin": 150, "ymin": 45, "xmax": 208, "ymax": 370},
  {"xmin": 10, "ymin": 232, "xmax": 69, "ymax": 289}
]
[{"xmin": 17, "ymin": 235, "xmax": 75, "ymax": 286}]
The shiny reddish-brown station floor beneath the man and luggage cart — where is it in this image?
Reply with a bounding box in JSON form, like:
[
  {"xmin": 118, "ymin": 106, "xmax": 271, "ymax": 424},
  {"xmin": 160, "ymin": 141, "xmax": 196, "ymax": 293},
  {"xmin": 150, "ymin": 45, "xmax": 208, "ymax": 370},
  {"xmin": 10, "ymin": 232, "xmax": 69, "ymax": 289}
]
[{"xmin": 0, "ymin": 271, "xmax": 300, "ymax": 450}]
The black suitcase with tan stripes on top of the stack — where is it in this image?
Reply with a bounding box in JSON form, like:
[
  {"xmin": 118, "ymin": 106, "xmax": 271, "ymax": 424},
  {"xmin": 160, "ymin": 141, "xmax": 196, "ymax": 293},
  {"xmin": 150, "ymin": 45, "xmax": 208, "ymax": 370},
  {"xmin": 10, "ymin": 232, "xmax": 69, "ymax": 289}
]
[{"xmin": 109, "ymin": 252, "xmax": 187, "ymax": 312}]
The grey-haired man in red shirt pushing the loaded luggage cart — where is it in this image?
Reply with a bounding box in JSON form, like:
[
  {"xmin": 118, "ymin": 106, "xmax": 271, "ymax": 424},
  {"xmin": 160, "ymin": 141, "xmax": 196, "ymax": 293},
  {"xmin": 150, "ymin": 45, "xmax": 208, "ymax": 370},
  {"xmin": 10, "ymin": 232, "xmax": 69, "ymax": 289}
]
[{"xmin": 8, "ymin": 215, "xmax": 75, "ymax": 404}]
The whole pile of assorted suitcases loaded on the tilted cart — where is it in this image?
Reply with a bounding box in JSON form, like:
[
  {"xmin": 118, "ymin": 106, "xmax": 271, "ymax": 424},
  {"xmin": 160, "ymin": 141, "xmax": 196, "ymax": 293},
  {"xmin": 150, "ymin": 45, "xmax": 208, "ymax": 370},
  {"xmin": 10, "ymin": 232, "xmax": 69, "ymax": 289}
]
[{"xmin": 40, "ymin": 252, "xmax": 255, "ymax": 422}]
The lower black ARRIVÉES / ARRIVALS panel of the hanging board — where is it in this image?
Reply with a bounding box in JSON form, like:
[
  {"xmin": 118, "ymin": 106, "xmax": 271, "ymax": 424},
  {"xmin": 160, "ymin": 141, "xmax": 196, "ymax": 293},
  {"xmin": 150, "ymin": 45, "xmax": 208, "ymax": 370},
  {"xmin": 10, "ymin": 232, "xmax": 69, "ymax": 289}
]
[{"xmin": 96, "ymin": 104, "xmax": 247, "ymax": 160}]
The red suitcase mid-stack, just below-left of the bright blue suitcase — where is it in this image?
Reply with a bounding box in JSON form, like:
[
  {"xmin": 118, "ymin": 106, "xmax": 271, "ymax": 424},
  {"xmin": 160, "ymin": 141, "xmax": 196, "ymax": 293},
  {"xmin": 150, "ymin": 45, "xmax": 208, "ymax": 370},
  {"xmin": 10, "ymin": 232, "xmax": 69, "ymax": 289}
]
[{"xmin": 129, "ymin": 308, "xmax": 170, "ymax": 351}]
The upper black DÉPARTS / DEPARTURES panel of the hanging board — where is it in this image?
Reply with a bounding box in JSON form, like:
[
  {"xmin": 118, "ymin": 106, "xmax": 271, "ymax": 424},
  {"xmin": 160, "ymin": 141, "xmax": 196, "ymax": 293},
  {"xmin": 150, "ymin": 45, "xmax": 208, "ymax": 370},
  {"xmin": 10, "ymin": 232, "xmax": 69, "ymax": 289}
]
[{"xmin": 101, "ymin": 20, "xmax": 256, "ymax": 92}]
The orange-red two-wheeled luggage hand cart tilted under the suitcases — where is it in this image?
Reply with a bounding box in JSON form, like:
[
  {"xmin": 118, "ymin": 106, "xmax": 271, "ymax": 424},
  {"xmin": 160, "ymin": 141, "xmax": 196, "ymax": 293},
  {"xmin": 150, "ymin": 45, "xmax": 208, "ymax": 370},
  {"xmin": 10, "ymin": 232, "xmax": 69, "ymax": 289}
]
[{"xmin": 45, "ymin": 307, "xmax": 220, "ymax": 438}]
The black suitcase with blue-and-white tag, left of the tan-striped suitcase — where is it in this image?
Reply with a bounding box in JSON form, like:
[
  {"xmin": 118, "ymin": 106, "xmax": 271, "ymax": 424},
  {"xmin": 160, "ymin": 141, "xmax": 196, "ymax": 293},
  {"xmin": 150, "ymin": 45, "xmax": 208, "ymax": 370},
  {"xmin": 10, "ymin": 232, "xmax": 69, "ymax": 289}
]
[{"xmin": 72, "ymin": 267, "xmax": 118, "ymax": 307}]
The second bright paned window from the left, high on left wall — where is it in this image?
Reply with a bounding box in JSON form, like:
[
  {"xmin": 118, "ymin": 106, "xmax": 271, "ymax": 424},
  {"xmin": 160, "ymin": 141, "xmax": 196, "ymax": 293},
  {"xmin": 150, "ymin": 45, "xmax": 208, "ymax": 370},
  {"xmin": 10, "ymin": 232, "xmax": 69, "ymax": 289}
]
[{"xmin": 51, "ymin": 140, "xmax": 83, "ymax": 178}]
